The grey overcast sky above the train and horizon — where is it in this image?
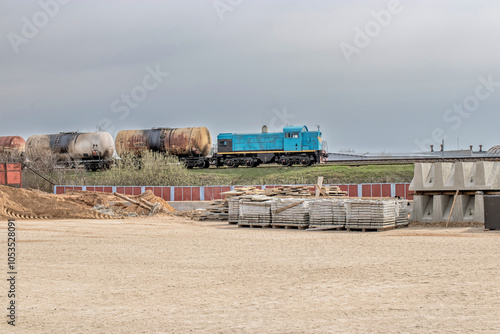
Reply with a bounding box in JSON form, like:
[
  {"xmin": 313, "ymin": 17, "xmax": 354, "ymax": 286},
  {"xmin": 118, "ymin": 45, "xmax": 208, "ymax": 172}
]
[{"xmin": 0, "ymin": 0, "xmax": 500, "ymax": 153}]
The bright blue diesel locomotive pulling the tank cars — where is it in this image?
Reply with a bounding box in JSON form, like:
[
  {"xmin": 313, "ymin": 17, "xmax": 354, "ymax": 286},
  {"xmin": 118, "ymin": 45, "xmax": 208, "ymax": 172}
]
[{"xmin": 213, "ymin": 125, "xmax": 328, "ymax": 167}]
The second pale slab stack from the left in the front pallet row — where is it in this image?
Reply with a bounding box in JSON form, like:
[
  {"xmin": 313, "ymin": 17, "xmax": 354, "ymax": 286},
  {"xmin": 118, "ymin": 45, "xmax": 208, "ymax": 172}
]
[{"xmin": 271, "ymin": 198, "xmax": 311, "ymax": 228}]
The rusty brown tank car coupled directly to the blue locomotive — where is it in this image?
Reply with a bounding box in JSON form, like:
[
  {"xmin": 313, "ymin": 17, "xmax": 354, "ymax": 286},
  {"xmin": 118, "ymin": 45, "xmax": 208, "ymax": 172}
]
[{"xmin": 115, "ymin": 127, "xmax": 212, "ymax": 168}]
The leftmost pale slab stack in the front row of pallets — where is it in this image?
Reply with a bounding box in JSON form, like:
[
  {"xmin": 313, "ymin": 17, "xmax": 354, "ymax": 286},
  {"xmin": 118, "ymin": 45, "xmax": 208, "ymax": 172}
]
[{"xmin": 238, "ymin": 195, "xmax": 272, "ymax": 227}]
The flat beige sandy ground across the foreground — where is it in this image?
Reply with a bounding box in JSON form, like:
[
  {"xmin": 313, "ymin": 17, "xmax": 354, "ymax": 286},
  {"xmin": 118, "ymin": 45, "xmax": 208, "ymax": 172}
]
[{"xmin": 0, "ymin": 217, "xmax": 500, "ymax": 333}]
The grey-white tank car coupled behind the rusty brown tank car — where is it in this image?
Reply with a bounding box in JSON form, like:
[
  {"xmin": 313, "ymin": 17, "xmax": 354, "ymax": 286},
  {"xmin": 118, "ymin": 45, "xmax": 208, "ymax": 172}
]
[{"xmin": 26, "ymin": 132, "xmax": 114, "ymax": 171}]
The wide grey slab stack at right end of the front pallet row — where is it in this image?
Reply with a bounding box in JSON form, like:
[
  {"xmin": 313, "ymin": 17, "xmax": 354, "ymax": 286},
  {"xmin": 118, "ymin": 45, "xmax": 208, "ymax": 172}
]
[{"xmin": 345, "ymin": 199, "xmax": 399, "ymax": 229}]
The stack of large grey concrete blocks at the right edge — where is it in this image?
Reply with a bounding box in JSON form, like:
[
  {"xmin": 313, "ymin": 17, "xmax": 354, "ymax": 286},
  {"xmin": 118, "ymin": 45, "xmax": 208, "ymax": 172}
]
[{"xmin": 410, "ymin": 161, "xmax": 500, "ymax": 223}]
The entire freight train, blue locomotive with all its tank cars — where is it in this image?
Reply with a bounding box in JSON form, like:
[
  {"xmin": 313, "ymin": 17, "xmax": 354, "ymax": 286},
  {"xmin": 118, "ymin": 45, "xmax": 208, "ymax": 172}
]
[{"xmin": 0, "ymin": 126, "xmax": 328, "ymax": 171}]
